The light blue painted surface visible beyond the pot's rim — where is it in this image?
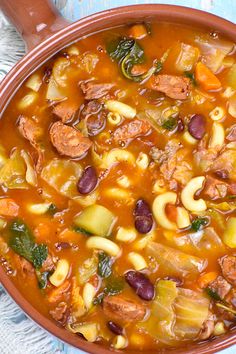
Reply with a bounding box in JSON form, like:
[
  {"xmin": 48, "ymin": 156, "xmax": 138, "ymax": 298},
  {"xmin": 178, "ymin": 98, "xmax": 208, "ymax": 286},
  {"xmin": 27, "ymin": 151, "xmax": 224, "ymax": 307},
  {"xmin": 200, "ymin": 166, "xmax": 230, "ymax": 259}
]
[{"xmin": 55, "ymin": 0, "xmax": 236, "ymax": 354}]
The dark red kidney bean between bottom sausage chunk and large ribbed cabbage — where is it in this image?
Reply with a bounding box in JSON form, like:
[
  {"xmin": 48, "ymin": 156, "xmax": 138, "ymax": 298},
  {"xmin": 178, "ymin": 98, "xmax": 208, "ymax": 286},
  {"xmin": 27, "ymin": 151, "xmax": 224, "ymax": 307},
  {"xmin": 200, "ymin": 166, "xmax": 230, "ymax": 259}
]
[{"xmin": 125, "ymin": 270, "xmax": 155, "ymax": 301}]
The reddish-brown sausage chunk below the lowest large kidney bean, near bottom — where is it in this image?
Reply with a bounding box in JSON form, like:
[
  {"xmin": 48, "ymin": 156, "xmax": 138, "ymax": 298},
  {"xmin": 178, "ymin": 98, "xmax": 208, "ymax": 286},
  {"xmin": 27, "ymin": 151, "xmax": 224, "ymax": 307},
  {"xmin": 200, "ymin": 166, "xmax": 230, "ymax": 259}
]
[{"xmin": 103, "ymin": 295, "xmax": 146, "ymax": 322}]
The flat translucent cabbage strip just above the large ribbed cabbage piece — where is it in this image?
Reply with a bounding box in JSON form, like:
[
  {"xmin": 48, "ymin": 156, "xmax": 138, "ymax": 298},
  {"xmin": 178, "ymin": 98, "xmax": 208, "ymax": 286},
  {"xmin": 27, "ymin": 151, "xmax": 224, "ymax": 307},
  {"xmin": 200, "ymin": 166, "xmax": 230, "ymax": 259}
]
[{"xmin": 146, "ymin": 242, "xmax": 206, "ymax": 279}]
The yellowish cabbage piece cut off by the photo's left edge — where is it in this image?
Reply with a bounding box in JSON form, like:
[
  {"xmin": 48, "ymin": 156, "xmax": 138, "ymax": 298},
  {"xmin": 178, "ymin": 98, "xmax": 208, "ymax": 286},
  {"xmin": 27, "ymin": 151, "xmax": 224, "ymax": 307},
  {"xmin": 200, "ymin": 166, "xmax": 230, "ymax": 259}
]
[{"xmin": 0, "ymin": 149, "xmax": 29, "ymax": 189}]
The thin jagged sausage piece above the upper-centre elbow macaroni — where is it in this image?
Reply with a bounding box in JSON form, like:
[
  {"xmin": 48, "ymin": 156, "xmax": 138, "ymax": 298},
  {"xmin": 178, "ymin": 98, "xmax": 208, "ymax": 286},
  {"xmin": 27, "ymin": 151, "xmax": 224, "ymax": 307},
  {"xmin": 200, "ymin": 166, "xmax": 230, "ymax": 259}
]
[{"xmin": 80, "ymin": 81, "xmax": 114, "ymax": 100}]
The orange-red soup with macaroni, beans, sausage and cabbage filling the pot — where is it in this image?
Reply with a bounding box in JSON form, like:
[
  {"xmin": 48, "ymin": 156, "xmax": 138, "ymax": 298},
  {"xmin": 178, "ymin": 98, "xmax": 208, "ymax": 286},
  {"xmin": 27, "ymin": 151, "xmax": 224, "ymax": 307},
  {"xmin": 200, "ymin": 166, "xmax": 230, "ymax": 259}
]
[{"xmin": 0, "ymin": 23, "xmax": 236, "ymax": 351}]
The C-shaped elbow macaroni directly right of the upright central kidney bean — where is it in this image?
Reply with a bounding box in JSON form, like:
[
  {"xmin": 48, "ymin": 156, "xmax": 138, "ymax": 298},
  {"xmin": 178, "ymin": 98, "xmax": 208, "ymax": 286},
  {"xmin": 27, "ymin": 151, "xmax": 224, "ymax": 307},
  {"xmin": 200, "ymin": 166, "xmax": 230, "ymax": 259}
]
[{"xmin": 152, "ymin": 192, "xmax": 177, "ymax": 230}]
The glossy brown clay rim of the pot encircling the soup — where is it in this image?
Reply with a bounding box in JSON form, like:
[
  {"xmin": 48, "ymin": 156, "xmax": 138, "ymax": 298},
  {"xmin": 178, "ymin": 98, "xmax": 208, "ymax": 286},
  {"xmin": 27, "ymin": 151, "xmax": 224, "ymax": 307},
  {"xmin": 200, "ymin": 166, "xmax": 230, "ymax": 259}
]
[{"xmin": 0, "ymin": 5, "xmax": 236, "ymax": 354}]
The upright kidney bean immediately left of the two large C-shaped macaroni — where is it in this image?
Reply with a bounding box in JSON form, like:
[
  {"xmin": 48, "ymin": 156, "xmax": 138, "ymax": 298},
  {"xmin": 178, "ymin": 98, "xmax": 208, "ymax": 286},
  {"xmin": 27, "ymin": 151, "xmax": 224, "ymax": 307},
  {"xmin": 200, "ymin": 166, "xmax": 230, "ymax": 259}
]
[{"xmin": 134, "ymin": 199, "xmax": 153, "ymax": 234}]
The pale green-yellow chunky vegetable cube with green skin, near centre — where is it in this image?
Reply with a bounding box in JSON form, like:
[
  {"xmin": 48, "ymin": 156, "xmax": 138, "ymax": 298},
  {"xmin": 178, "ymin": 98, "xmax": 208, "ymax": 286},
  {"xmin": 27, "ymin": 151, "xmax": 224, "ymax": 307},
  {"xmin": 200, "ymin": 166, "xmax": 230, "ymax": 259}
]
[{"xmin": 74, "ymin": 204, "xmax": 115, "ymax": 236}]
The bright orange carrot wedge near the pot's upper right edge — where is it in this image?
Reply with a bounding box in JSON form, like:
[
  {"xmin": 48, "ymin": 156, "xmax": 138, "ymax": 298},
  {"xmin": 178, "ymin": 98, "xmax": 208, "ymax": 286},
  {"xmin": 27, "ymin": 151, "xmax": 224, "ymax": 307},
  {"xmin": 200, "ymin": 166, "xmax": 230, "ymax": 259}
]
[{"xmin": 195, "ymin": 62, "xmax": 221, "ymax": 91}]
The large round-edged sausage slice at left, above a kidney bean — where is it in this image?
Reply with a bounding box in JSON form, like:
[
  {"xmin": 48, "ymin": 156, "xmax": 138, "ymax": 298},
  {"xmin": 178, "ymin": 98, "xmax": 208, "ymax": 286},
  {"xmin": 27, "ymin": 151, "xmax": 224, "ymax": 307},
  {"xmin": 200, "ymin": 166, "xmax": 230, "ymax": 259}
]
[{"xmin": 49, "ymin": 122, "xmax": 92, "ymax": 157}]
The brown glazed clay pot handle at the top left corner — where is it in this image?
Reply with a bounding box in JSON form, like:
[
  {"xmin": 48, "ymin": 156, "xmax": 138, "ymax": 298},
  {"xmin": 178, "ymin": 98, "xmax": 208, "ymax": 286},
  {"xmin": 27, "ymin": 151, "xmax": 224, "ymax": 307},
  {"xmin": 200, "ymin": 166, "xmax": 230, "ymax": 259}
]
[{"xmin": 0, "ymin": 0, "xmax": 69, "ymax": 51}]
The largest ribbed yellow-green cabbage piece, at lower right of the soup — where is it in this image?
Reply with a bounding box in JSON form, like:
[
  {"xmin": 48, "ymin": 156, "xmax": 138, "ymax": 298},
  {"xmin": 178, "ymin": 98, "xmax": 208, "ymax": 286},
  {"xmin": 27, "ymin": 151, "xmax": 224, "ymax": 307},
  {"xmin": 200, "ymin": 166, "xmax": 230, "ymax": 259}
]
[{"xmin": 139, "ymin": 280, "xmax": 210, "ymax": 345}]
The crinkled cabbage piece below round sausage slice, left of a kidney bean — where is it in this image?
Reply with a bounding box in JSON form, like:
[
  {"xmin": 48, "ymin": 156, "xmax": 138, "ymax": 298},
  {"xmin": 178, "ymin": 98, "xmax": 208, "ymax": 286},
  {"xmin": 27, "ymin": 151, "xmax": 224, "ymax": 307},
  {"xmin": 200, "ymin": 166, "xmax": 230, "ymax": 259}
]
[{"xmin": 41, "ymin": 158, "xmax": 82, "ymax": 198}]
